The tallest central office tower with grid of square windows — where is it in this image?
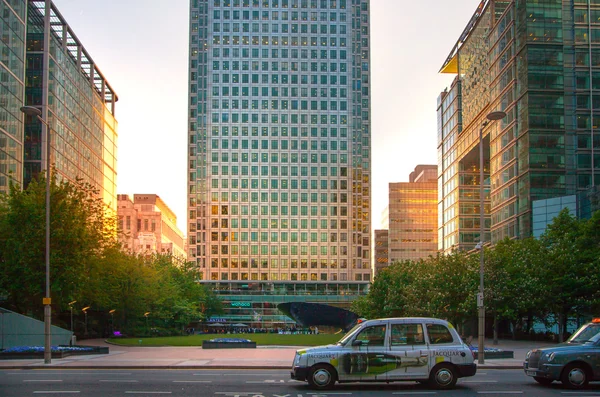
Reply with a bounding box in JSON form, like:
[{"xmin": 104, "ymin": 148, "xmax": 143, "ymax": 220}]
[{"xmin": 188, "ymin": 0, "xmax": 371, "ymax": 326}]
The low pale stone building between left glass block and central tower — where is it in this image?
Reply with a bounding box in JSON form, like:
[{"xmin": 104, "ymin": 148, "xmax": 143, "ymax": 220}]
[{"xmin": 117, "ymin": 194, "xmax": 187, "ymax": 264}]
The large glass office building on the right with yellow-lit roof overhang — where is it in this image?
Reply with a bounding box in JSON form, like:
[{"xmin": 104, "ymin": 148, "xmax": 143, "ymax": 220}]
[{"xmin": 438, "ymin": 0, "xmax": 600, "ymax": 252}]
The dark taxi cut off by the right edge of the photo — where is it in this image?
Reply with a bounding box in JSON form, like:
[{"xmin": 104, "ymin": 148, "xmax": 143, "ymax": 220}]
[{"xmin": 523, "ymin": 318, "xmax": 600, "ymax": 389}]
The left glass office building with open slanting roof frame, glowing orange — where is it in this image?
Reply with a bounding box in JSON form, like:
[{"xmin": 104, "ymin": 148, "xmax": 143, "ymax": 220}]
[{"xmin": 23, "ymin": 0, "xmax": 118, "ymax": 213}]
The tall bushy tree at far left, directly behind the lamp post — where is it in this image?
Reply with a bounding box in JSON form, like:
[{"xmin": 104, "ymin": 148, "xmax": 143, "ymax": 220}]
[{"xmin": 0, "ymin": 174, "xmax": 114, "ymax": 318}]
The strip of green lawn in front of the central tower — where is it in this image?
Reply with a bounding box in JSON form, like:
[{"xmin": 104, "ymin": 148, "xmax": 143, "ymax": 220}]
[{"xmin": 108, "ymin": 334, "xmax": 344, "ymax": 346}]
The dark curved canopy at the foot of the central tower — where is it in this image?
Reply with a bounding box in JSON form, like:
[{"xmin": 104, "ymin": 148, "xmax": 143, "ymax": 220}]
[{"xmin": 277, "ymin": 302, "xmax": 358, "ymax": 330}]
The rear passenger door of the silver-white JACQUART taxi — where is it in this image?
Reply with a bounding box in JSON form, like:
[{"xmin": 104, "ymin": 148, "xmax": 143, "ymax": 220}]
[{"xmin": 387, "ymin": 322, "xmax": 429, "ymax": 380}]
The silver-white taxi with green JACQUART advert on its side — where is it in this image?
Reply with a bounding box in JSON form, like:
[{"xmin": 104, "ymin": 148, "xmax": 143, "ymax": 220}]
[{"xmin": 291, "ymin": 318, "xmax": 477, "ymax": 389}]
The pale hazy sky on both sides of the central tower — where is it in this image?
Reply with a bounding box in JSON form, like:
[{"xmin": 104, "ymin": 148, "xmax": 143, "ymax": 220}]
[{"xmin": 54, "ymin": 0, "xmax": 480, "ymax": 234}]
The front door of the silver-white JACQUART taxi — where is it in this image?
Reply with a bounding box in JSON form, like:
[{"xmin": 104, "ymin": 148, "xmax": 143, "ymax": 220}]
[{"xmin": 338, "ymin": 324, "xmax": 388, "ymax": 381}]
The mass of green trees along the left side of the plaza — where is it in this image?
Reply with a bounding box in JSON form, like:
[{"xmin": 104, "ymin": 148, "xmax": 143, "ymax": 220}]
[{"xmin": 0, "ymin": 176, "xmax": 223, "ymax": 330}]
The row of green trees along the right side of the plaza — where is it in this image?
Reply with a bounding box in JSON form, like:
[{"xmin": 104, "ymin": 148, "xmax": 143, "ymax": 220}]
[{"xmin": 352, "ymin": 210, "xmax": 600, "ymax": 333}]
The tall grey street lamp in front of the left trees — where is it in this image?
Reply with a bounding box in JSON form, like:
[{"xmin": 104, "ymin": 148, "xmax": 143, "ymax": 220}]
[{"xmin": 21, "ymin": 106, "xmax": 52, "ymax": 364}]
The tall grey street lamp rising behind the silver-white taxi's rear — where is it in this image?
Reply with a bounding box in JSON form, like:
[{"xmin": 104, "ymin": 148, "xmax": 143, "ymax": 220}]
[{"xmin": 476, "ymin": 111, "xmax": 506, "ymax": 364}]
